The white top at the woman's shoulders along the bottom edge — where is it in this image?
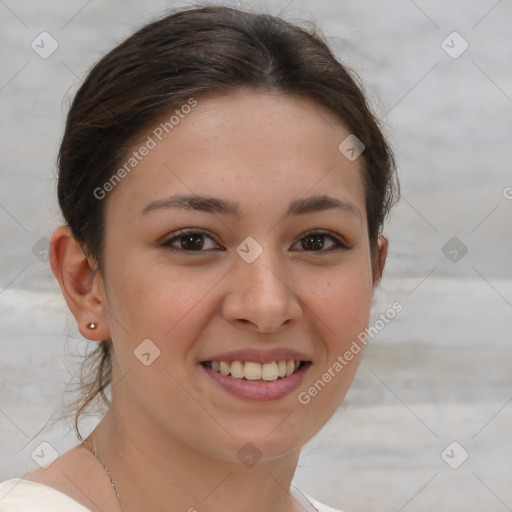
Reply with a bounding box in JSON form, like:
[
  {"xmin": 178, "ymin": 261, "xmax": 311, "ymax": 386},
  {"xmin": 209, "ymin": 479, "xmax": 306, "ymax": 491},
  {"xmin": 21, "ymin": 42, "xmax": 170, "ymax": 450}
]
[{"xmin": 0, "ymin": 478, "xmax": 341, "ymax": 512}]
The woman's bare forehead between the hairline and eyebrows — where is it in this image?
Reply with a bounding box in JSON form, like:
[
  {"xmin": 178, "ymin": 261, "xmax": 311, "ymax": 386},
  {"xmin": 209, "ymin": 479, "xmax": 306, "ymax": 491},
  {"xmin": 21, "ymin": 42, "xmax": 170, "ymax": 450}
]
[{"xmin": 108, "ymin": 90, "xmax": 364, "ymax": 222}]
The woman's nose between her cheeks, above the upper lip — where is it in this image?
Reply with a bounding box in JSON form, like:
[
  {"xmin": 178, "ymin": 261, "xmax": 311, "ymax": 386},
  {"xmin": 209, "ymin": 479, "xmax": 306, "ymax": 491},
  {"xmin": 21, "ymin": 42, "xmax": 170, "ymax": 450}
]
[{"xmin": 222, "ymin": 251, "xmax": 302, "ymax": 333}]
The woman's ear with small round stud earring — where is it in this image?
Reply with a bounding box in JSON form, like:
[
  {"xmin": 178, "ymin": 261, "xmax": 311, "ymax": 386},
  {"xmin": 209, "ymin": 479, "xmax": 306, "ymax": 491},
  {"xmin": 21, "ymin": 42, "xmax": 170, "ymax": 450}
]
[{"xmin": 50, "ymin": 226, "xmax": 110, "ymax": 341}]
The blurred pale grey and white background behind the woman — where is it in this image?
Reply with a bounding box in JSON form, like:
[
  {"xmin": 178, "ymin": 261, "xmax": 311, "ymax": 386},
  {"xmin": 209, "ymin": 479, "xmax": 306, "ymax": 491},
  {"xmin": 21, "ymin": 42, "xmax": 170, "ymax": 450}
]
[{"xmin": 0, "ymin": 0, "xmax": 512, "ymax": 512}]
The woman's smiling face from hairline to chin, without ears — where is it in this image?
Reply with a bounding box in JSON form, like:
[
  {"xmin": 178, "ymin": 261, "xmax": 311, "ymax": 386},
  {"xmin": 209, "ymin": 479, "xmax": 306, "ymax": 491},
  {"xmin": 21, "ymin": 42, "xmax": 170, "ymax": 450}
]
[{"xmin": 98, "ymin": 91, "xmax": 380, "ymax": 460}]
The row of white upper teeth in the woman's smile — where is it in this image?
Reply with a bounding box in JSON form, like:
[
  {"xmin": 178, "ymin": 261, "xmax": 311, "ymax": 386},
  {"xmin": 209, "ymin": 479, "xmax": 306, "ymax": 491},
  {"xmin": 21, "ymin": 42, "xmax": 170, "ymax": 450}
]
[{"xmin": 211, "ymin": 359, "xmax": 300, "ymax": 381}]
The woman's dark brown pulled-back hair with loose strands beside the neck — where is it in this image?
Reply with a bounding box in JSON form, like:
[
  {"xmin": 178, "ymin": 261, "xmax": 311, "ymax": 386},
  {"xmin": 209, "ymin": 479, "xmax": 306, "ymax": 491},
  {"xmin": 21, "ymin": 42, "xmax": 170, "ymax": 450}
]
[{"xmin": 58, "ymin": 5, "xmax": 399, "ymax": 439}]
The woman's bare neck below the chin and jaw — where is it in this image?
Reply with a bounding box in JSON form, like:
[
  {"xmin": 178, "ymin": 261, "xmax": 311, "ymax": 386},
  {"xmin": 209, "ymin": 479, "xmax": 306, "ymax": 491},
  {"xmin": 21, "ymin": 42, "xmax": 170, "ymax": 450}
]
[{"xmin": 90, "ymin": 399, "xmax": 308, "ymax": 512}]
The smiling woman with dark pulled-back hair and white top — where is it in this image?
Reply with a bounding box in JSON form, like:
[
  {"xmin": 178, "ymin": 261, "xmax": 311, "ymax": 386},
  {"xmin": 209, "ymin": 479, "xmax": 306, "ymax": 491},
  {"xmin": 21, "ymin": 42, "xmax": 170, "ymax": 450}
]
[{"xmin": 0, "ymin": 6, "xmax": 398, "ymax": 512}]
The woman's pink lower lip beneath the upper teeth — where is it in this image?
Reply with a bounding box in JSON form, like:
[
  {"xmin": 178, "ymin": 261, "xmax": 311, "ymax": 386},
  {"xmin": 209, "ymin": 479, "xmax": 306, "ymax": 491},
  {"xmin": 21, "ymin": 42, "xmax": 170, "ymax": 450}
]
[{"xmin": 199, "ymin": 363, "xmax": 311, "ymax": 401}]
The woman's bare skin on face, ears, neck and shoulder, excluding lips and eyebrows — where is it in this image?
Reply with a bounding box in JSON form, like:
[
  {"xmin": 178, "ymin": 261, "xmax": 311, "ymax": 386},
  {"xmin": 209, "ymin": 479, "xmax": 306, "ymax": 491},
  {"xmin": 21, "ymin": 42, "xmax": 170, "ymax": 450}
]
[{"xmin": 26, "ymin": 90, "xmax": 387, "ymax": 512}]
